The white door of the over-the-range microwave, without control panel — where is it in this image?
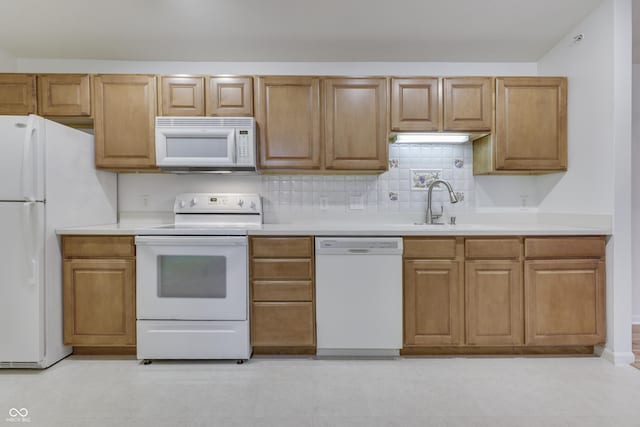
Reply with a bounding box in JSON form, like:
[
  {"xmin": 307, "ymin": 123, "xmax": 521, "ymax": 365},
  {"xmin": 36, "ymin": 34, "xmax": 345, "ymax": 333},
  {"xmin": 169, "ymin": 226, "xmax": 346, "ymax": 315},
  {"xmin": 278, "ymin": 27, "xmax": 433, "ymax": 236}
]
[{"xmin": 156, "ymin": 128, "xmax": 236, "ymax": 167}]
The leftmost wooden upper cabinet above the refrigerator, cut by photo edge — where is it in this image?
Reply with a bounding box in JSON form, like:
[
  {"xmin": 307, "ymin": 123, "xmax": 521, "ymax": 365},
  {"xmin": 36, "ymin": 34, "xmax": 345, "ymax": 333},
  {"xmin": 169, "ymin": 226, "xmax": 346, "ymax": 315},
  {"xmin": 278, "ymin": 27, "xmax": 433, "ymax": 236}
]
[{"xmin": 0, "ymin": 74, "xmax": 36, "ymax": 115}]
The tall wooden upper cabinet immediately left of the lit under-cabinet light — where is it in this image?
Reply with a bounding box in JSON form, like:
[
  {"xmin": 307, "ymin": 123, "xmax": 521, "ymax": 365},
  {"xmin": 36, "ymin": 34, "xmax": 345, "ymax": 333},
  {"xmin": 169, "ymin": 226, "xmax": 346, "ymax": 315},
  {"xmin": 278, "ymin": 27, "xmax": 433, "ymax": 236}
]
[{"xmin": 323, "ymin": 78, "xmax": 388, "ymax": 171}]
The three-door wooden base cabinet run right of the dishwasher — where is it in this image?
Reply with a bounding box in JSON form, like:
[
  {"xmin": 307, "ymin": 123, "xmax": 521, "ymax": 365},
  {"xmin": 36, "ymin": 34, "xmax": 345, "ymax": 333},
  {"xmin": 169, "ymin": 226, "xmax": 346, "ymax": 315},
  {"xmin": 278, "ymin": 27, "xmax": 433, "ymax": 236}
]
[{"xmin": 402, "ymin": 236, "xmax": 605, "ymax": 355}]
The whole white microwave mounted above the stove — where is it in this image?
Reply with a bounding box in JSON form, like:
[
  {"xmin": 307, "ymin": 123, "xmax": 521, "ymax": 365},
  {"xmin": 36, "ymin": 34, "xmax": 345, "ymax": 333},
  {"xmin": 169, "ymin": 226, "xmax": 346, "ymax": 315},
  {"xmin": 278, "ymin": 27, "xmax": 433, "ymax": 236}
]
[{"xmin": 156, "ymin": 117, "xmax": 256, "ymax": 172}]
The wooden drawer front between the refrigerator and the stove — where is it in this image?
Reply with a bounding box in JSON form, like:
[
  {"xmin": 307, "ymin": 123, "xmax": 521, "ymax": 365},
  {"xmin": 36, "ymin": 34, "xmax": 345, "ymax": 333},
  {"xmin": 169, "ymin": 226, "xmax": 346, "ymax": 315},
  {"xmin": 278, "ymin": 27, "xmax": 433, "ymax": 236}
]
[{"xmin": 62, "ymin": 236, "xmax": 135, "ymax": 258}]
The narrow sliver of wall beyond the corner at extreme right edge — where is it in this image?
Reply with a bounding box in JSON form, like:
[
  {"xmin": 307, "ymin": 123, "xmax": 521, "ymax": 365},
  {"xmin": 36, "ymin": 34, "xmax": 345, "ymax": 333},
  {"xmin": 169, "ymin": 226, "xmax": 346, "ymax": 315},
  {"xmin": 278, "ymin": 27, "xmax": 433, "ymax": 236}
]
[{"xmin": 631, "ymin": 64, "xmax": 640, "ymax": 324}]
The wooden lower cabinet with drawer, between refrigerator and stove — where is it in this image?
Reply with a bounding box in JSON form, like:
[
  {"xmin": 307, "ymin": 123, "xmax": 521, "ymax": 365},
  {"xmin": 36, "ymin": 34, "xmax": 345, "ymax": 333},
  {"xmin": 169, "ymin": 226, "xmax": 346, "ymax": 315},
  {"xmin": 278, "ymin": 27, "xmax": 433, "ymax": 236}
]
[{"xmin": 62, "ymin": 236, "xmax": 136, "ymax": 354}]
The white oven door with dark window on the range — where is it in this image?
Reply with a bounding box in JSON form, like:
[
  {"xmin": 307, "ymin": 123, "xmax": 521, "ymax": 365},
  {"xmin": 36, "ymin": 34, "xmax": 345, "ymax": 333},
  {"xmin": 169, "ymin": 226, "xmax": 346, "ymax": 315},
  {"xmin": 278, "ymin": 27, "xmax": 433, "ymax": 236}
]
[{"xmin": 136, "ymin": 236, "xmax": 248, "ymax": 320}]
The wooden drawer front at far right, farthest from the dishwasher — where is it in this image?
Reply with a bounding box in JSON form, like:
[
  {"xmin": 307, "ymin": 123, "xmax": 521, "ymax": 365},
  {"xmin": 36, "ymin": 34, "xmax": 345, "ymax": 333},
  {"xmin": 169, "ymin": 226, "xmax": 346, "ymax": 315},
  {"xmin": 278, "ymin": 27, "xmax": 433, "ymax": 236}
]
[{"xmin": 524, "ymin": 236, "xmax": 605, "ymax": 258}]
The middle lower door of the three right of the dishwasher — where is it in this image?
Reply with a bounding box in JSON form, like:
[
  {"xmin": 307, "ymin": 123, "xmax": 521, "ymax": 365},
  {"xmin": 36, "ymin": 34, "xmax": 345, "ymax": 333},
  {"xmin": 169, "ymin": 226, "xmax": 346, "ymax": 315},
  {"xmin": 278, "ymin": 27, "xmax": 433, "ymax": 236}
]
[{"xmin": 465, "ymin": 261, "xmax": 524, "ymax": 345}]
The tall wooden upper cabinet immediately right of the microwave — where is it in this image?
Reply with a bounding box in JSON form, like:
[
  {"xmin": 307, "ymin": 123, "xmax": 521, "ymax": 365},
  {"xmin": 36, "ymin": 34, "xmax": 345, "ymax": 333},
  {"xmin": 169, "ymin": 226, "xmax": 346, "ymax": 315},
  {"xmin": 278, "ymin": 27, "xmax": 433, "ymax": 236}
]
[{"xmin": 255, "ymin": 77, "xmax": 321, "ymax": 169}]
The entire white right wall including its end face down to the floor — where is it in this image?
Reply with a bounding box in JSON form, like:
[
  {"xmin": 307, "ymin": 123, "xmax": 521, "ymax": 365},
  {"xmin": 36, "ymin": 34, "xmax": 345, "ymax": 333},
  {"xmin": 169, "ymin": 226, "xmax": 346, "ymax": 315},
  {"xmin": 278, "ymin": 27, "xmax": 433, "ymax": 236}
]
[{"xmin": 538, "ymin": 0, "xmax": 634, "ymax": 363}]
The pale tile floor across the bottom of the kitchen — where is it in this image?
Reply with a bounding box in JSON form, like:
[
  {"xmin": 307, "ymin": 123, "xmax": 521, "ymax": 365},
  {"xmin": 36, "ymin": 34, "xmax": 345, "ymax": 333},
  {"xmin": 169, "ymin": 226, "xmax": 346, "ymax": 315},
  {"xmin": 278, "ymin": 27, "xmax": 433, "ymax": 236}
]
[{"xmin": 0, "ymin": 357, "xmax": 640, "ymax": 427}]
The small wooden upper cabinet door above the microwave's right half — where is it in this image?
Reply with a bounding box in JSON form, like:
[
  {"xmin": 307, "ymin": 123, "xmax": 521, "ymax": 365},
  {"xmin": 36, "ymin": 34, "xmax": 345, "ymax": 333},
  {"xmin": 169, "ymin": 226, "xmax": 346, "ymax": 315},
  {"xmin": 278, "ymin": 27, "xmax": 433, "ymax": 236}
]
[{"xmin": 206, "ymin": 76, "xmax": 253, "ymax": 117}]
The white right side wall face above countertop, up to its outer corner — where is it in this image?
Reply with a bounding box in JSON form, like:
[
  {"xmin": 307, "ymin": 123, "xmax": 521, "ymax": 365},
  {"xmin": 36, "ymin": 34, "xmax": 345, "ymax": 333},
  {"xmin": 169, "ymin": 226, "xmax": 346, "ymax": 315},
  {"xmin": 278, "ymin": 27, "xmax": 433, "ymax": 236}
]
[{"xmin": 538, "ymin": 1, "xmax": 614, "ymax": 214}]
